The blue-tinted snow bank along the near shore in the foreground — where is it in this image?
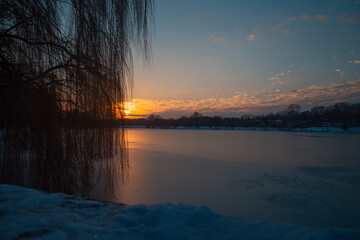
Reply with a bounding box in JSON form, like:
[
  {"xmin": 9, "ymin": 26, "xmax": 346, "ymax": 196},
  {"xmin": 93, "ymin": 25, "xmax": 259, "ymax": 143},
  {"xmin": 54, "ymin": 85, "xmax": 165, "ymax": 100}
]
[{"xmin": 0, "ymin": 185, "xmax": 360, "ymax": 240}]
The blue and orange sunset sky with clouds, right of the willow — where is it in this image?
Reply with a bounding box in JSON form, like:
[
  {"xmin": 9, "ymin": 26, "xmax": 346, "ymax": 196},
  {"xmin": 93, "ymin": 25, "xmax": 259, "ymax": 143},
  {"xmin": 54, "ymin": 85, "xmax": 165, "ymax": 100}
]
[{"xmin": 128, "ymin": 0, "xmax": 360, "ymax": 118}]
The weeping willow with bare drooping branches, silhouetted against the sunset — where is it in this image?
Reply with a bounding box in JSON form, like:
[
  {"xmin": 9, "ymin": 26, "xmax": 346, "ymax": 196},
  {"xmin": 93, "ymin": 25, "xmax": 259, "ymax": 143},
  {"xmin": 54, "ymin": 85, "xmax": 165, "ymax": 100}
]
[{"xmin": 0, "ymin": 0, "xmax": 153, "ymax": 199}]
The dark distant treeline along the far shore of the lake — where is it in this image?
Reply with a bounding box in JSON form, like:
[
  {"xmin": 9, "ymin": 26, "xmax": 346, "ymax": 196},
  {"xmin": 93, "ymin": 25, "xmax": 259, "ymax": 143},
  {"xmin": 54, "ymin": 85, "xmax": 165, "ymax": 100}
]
[{"xmin": 125, "ymin": 102, "xmax": 360, "ymax": 130}]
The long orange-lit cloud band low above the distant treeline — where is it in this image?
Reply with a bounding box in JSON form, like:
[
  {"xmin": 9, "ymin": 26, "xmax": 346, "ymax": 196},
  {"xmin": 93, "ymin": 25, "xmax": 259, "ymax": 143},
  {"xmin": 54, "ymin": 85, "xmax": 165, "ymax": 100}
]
[{"xmin": 128, "ymin": 79, "xmax": 360, "ymax": 117}]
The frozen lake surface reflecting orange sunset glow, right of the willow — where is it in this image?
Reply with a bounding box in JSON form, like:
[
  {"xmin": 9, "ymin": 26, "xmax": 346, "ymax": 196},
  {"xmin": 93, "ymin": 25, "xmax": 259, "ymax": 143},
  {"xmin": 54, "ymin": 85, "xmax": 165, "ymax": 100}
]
[{"xmin": 105, "ymin": 129, "xmax": 360, "ymax": 229}]
